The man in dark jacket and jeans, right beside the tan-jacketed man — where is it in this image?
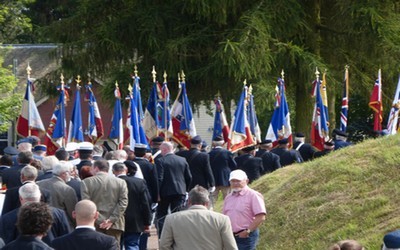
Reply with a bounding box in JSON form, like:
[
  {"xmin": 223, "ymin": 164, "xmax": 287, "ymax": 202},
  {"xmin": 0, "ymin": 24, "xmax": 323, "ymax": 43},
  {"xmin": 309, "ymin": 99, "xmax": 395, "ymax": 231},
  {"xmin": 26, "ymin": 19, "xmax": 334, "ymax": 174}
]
[{"xmin": 113, "ymin": 162, "xmax": 151, "ymax": 249}]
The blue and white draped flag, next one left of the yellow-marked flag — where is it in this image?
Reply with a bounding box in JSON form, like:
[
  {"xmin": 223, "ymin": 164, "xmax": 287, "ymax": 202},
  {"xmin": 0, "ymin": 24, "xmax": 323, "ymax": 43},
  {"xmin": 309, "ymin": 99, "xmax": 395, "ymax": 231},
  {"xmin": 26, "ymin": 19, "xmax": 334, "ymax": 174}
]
[{"xmin": 265, "ymin": 78, "xmax": 292, "ymax": 146}]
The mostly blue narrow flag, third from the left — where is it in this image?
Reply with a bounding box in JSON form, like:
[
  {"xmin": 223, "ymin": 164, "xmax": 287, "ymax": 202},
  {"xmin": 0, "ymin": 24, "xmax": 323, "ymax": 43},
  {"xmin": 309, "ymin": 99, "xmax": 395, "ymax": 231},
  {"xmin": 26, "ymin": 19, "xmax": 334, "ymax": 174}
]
[{"xmin": 67, "ymin": 84, "xmax": 84, "ymax": 142}]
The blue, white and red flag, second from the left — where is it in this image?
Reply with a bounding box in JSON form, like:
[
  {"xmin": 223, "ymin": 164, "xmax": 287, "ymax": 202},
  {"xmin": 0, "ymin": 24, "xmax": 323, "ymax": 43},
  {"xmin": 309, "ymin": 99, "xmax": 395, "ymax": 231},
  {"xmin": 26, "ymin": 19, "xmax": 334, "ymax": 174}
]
[{"xmin": 44, "ymin": 82, "xmax": 68, "ymax": 155}]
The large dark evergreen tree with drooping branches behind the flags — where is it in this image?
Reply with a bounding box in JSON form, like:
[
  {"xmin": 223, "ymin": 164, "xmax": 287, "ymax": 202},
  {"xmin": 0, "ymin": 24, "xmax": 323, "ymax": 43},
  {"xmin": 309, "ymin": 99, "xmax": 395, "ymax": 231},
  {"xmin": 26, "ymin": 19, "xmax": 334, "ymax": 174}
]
[{"xmin": 25, "ymin": 0, "xmax": 400, "ymax": 139}]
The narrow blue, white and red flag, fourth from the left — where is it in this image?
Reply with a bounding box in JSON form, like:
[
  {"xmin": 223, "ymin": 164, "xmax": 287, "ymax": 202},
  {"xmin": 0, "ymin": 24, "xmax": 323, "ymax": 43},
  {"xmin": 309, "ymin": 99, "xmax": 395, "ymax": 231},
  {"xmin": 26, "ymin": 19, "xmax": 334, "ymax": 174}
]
[{"xmin": 85, "ymin": 82, "xmax": 104, "ymax": 144}]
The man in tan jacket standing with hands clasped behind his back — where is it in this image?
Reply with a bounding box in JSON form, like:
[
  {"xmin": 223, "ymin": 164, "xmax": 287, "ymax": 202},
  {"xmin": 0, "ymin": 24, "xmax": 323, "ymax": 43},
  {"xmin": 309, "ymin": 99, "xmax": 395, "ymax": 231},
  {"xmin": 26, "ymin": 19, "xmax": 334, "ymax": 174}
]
[{"xmin": 81, "ymin": 160, "xmax": 128, "ymax": 242}]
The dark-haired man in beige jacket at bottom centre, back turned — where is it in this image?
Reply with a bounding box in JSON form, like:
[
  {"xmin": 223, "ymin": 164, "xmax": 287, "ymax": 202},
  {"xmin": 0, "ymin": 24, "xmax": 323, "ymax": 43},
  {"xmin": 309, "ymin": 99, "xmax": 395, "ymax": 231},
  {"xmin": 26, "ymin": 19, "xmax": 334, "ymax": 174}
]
[{"xmin": 160, "ymin": 186, "xmax": 237, "ymax": 250}]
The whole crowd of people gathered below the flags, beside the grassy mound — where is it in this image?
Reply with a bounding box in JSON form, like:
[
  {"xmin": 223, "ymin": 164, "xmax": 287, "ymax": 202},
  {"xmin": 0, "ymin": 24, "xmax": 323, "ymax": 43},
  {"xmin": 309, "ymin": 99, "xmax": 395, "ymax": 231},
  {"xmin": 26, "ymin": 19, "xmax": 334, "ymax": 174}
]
[{"xmin": 0, "ymin": 128, "xmax": 390, "ymax": 250}]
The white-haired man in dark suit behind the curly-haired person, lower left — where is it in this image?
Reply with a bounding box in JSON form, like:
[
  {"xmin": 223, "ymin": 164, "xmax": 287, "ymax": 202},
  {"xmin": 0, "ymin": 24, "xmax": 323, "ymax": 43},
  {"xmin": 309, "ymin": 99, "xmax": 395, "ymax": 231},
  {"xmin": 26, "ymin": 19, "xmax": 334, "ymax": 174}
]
[{"xmin": 0, "ymin": 182, "xmax": 71, "ymax": 244}]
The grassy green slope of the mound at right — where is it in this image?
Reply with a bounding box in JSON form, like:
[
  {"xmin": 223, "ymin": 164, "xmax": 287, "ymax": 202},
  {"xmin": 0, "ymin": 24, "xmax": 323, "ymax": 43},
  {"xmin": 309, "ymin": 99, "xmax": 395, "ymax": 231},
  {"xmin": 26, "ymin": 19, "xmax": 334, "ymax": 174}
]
[{"xmin": 252, "ymin": 136, "xmax": 400, "ymax": 250}]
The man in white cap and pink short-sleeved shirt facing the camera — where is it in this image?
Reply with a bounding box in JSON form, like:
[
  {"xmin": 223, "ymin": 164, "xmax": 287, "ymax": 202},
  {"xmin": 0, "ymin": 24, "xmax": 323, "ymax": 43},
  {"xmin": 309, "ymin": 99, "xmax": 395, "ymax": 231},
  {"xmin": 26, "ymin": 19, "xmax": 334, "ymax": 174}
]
[{"xmin": 222, "ymin": 169, "xmax": 267, "ymax": 250}]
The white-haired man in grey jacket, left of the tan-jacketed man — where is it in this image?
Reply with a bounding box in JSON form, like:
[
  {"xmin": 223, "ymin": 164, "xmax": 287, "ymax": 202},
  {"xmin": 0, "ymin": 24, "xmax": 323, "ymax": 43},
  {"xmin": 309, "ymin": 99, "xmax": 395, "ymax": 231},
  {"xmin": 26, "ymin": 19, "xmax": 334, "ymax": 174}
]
[{"xmin": 37, "ymin": 161, "xmax": 78, "ymax": 227}]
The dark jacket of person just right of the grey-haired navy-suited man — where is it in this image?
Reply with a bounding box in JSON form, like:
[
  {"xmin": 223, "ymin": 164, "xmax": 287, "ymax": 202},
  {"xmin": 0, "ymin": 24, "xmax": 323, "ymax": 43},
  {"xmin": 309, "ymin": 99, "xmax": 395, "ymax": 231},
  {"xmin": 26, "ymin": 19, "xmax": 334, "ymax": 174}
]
[{"xmin": 179, "ymin": 148, "xmax": 215, "ymax": 190}]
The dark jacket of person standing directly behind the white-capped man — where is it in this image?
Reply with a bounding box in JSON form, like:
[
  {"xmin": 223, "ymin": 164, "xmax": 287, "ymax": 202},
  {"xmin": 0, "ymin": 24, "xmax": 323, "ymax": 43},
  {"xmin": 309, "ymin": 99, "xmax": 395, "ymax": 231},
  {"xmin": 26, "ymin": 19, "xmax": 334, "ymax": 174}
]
[{"xmin": 208, "ymin": 147, "xmax": 236, "ymax": 187}]
